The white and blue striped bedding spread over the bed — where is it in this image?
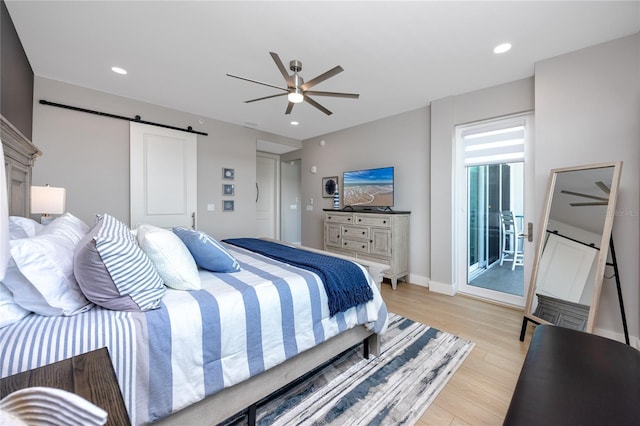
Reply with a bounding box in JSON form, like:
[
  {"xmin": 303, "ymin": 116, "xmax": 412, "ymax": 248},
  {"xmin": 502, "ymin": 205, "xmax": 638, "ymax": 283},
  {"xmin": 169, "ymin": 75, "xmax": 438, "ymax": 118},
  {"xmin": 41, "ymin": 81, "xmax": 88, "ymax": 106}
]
[{"xmin": 0, "ymin": 246, "xmax": 387, "ymax": 424}]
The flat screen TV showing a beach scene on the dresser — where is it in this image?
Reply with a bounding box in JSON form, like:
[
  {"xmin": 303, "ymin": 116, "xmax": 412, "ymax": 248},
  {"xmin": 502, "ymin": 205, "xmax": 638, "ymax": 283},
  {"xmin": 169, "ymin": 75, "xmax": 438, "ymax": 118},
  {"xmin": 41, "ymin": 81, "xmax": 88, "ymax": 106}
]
[{"xmin": 342, "ymin": 167, "xmax": 393, "ymax": 209}]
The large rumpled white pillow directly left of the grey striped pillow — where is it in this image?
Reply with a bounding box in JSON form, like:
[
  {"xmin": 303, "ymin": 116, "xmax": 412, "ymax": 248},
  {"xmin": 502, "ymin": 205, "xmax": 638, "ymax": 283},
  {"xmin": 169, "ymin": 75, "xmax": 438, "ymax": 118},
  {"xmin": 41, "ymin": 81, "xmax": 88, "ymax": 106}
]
[{"xmin": 3, "ymin": 213, "xmax": 93, "ymax": 316}]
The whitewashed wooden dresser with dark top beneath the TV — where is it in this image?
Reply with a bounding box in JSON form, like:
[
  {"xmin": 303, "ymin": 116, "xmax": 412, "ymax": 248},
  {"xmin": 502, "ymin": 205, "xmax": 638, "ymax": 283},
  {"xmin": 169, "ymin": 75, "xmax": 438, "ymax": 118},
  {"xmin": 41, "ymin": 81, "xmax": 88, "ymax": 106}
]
[{"xmin": 324, "ymin": 209, "xmax": 410, "ymax": 290}]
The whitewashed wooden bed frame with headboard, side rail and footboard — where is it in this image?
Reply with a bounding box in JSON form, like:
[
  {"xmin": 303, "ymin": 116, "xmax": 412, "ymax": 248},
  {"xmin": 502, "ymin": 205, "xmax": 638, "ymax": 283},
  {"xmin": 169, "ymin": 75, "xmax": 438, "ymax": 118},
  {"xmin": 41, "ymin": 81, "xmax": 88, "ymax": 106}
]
[{"xmin": 0, "ymin": 115, "xmax": 389, "ymax": 425}]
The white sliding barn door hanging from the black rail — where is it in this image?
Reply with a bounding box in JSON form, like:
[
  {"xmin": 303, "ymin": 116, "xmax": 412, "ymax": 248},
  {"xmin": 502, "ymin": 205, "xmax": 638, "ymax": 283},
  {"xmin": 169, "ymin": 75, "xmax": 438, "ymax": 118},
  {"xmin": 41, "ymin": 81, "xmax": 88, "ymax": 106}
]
[{"xmin": 130, "ymin": 122, "xmax": 198, "ymax": 228}]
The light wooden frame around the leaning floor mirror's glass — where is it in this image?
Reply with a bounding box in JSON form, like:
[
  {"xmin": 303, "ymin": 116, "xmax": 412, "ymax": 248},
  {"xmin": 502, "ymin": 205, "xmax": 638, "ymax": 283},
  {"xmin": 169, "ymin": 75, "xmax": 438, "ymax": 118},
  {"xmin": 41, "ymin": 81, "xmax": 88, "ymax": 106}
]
[{"xmin": 520, "ymin": 161, "xmax": 622, "ymax": 332}]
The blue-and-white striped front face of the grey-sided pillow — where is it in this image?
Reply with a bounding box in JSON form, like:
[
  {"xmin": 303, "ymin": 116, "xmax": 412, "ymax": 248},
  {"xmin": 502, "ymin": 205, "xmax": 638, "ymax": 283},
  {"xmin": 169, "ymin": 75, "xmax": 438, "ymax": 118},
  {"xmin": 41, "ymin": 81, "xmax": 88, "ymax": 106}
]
[{"xmin": 95, "ymin": 214, "xmax": 167, "ymax": 311}]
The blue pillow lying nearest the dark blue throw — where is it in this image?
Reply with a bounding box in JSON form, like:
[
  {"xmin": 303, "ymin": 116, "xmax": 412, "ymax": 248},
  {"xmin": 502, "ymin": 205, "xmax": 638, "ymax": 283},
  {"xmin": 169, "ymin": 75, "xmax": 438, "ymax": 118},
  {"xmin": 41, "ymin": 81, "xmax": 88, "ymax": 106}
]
[{"xmin": 173, "ymin": 227, "xmax": 240, "ymax": 272}]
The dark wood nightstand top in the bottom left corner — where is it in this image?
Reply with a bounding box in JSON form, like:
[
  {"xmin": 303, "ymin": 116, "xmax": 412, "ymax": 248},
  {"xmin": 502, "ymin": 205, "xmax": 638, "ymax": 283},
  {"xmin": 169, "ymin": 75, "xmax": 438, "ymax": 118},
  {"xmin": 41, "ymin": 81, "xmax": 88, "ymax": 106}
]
[{"xmin": 0, "ymin": 348, "xmax": 131, "ymax": 426}]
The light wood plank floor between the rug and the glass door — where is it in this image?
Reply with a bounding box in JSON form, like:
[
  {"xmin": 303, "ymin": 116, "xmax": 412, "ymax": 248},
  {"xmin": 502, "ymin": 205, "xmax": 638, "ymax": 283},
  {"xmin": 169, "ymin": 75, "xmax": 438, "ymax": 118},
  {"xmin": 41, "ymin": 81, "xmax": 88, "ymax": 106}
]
[{"xmin": 382, "ymin": 282, "xmax": 533, "ymax": 426}]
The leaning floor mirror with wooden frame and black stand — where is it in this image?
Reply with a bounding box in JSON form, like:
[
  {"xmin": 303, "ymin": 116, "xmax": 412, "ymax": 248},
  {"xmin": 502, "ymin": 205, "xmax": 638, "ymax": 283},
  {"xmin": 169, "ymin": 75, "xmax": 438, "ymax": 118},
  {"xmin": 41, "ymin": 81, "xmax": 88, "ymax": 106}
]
[{"xmin": 520, "ymin": 162, "xmax": 624, "ymax": 341}]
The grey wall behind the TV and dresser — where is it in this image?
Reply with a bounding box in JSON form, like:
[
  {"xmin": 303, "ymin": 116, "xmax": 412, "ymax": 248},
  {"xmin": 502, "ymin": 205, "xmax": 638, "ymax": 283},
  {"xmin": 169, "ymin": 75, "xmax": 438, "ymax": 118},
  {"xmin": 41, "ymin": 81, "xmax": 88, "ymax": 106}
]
[{"xmin": 302, "ymin": 107, "xmax": 430, "ymax": 285}]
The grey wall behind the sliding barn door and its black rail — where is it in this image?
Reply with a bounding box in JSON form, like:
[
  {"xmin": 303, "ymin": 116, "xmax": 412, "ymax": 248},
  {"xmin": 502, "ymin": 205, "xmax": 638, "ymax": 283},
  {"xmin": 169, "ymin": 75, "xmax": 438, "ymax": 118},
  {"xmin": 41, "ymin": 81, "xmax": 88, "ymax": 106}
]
[{"xmin": 33, "ymin": 77, "xmax": 300, "ymax": 239}]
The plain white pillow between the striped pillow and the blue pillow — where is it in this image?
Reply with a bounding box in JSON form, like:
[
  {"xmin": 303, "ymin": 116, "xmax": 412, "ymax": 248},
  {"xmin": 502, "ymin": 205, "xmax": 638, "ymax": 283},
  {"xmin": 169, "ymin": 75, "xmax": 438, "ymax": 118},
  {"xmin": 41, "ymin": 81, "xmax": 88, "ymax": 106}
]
[{"xmin": 137, "ymin": 225, "xmax": 202, "ymax": 290}]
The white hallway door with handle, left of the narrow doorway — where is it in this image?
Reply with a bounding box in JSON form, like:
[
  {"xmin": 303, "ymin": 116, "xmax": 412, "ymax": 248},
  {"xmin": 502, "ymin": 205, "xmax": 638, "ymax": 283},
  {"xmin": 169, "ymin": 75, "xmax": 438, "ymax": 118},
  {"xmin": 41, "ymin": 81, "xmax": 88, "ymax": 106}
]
[{"xmin": 256, "ymin": 152, "xmax": 280, "ymax": 239}]
